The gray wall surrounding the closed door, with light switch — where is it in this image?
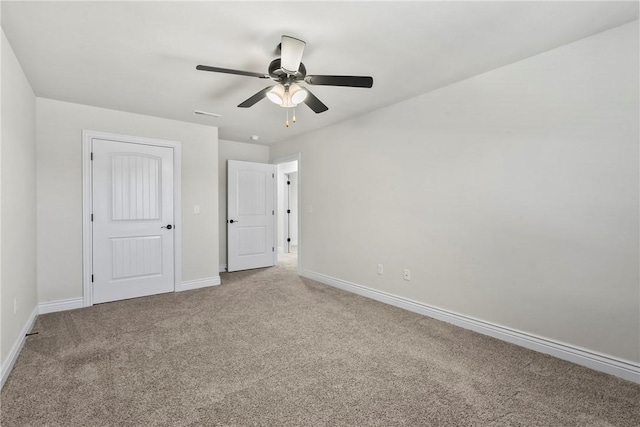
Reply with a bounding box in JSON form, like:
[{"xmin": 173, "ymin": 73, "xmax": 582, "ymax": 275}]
[{"xmin": 36, "ymin": 98, "xmax": 219, "ymax": 302}]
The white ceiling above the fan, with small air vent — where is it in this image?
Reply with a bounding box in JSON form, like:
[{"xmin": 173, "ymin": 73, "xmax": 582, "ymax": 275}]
[{"xmin": 2, "ymin": 0, "xmax": 638, "ymax": 144}]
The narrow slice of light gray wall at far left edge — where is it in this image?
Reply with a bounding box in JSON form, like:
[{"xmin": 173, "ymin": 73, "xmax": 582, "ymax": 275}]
[{"xmin": 0, "ymin": 31, "xmax": 37, "ymax": 371}]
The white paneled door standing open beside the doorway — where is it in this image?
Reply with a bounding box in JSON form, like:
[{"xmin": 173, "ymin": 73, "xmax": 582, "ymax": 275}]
[{"xmin": 227, "ymin": 160, "xmax": 276, "ymax": 271}]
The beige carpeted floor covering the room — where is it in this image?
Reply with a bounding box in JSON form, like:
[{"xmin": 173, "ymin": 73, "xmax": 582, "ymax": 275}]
[{"xmin": 1, "ymin": 260, "xmax": 640, "ymax": 427}]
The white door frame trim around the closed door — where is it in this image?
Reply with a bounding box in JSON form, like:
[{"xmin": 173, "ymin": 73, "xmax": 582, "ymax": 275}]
[{"xmin": 82, "ymin": 130, "xmax": 182, "ymax": 307}]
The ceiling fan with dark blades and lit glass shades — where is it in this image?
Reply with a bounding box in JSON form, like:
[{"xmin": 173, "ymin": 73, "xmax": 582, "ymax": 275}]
[{"xmin": 196, "ymin": 35, "xmax": 373, "ymax": 126}]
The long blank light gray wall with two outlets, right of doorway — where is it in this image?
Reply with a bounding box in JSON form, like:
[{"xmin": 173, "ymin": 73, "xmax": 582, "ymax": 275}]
[{"xmin": 271, "ymin": 21, "xmax": 640, "ymax": 363}]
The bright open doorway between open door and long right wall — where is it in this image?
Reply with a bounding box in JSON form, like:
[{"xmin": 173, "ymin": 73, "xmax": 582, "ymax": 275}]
[{"xmin": 273, "ymin": 154, "xmax": 300, "ymax": 268}]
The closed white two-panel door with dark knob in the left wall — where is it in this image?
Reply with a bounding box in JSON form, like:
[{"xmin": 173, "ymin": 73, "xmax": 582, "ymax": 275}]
[{"xmin": 92, "ymin": 139, "xmax": 175, "ymax": 304}]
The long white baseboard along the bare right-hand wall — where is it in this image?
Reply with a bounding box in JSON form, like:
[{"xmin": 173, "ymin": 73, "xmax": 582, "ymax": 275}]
[{"xmin": 301, "ymin": 270, "xmax": 640, "ymax": 384}]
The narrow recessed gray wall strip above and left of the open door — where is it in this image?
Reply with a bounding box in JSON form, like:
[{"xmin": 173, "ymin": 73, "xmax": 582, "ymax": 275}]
[{"xmin": 218, "ymin": 139, "xmax": 269, "ymax": 269}]
